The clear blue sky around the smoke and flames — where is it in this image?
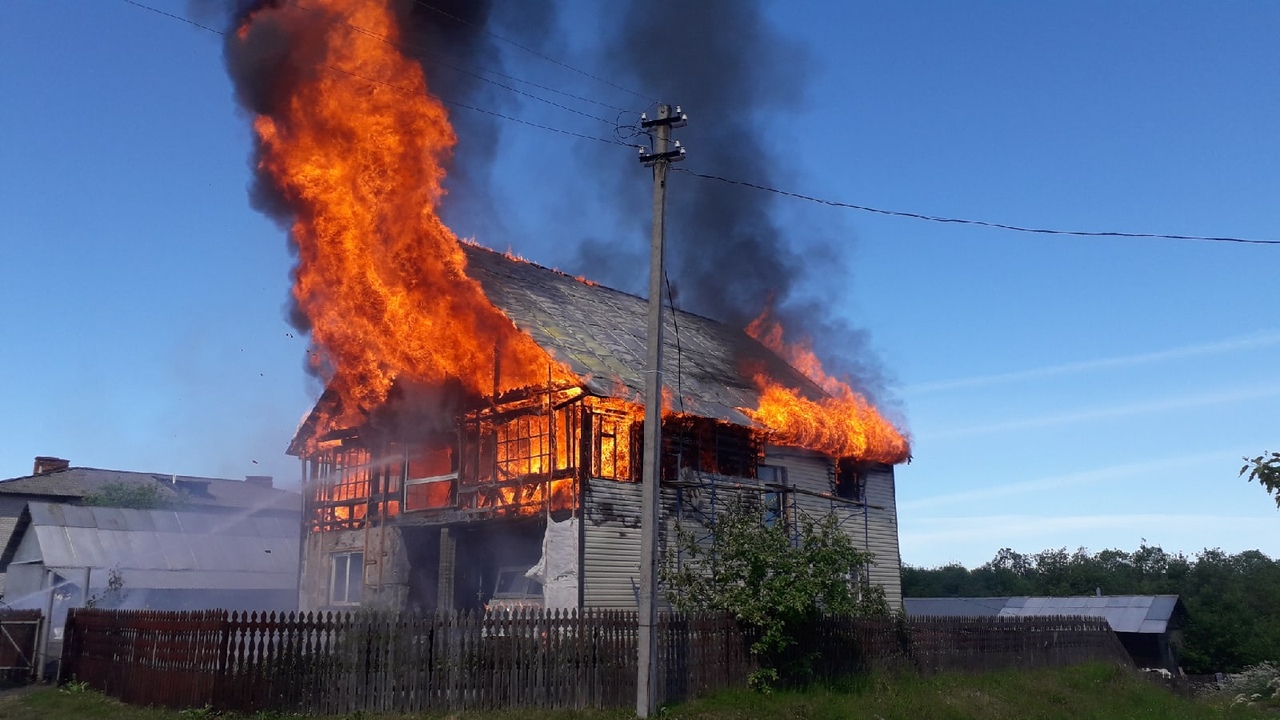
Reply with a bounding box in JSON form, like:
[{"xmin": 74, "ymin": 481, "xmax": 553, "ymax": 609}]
[{"xmin": 0, "ymin": 0, "xmax": 1280, "ymax": 565}]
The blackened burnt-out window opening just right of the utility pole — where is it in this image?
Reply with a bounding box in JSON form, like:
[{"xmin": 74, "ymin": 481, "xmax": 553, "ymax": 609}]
[{"xmin": 662, "ymin": 415, "xmax": 762, "ymax": 480}]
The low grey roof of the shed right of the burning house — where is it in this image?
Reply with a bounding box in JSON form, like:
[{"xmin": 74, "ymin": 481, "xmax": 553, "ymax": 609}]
[{"xmin": 902, "ymin": 594, "xmax": 1185, "ymax": 633}]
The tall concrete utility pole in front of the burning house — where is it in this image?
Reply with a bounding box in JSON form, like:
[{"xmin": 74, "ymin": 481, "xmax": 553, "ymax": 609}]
[{"xmin": 636, "ymin": 105, "xmax": 687, "ymax": 717}]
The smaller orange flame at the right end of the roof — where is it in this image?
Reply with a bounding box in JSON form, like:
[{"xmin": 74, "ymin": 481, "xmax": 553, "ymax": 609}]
[{"xmin": 742, "ymin": 310, "xmax": 911, "ymax": 464}]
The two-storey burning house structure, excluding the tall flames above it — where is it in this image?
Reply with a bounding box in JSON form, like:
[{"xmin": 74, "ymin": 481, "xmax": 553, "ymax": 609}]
[{"xmin": 288, "ymin": 246, "xmax": 901, "ymax": 611}]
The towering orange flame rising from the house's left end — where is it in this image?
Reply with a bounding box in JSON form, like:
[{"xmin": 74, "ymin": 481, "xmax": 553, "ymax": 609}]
[{"xmin": 236, "ymin": 0, "xmax": 571, "ymax": 421}]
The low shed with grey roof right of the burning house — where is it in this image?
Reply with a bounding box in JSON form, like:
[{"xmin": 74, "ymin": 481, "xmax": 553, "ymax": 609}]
[{"xmin": 902, "ymin": 594, "xmax": 1187, "ymax": 674}]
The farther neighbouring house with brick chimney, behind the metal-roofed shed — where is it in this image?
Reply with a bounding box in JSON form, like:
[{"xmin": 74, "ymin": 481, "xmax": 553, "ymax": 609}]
[{"xmin": 0, "ymin": 456, "xmax": 302, "ymax": 600}]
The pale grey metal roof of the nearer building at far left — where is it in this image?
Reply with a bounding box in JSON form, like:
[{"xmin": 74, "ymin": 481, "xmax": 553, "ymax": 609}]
[{"xmin": 0, "ymin": 502, "xmax": 300, "ymax": 589}]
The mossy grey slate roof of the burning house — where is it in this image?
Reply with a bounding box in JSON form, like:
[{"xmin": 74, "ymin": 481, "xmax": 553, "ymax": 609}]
[{"xmin": 285, "ymin": 242, "xmax": 827, "ymax": 456}]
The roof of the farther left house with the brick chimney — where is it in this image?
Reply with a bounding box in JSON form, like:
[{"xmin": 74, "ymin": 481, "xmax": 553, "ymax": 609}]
[{"xmin": 0, "ymin": 468, "xmax": 301, "ymax": 515}]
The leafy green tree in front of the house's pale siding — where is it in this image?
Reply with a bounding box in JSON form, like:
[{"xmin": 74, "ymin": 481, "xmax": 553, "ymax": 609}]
[{"xmin": 660, "ymin": 498, "xmax": 888, "ymax": 691}]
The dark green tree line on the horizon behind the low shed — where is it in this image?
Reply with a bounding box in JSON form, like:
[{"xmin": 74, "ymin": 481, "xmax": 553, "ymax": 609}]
[{"xmin": 902, "ymin": 542, "xmax": 1280, "ymax": 674}]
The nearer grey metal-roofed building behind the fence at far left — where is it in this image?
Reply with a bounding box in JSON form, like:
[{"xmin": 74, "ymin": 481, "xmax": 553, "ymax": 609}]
[{"xmin": 0, "ymin": 501, "xmax": 300, "ymax": 609}]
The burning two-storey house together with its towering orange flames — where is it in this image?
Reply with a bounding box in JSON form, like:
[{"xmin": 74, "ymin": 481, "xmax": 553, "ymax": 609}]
[{"xmin": 225, "ymin": 0, "xmax": 910, "ymax": 610}]
